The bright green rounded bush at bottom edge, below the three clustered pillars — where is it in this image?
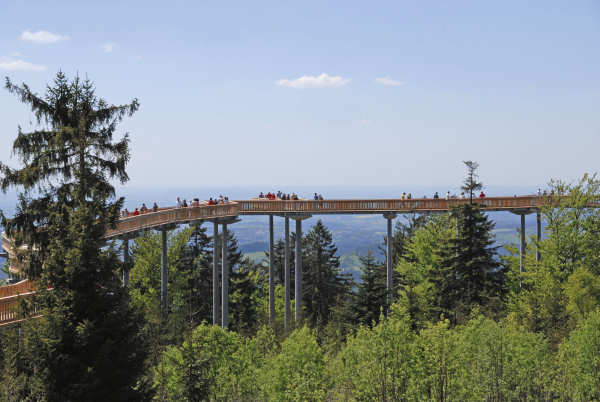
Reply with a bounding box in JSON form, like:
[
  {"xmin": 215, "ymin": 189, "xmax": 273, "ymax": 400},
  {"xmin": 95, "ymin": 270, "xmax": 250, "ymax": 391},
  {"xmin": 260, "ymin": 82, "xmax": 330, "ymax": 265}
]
[{"xmin": 259, "ymin": 327, "xmax": 330, "ymax": 401}]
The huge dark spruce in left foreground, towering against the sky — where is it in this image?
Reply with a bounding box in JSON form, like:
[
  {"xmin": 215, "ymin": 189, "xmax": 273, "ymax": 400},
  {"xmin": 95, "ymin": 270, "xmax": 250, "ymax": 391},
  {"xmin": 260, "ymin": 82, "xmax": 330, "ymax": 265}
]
[{"xmin": 0, "ymin": 72, "xmax": 145, "ymax": 401}]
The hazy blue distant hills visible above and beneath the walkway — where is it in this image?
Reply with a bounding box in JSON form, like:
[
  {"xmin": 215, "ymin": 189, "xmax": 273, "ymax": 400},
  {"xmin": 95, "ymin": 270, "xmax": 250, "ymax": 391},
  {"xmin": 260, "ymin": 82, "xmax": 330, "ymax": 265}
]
[{"xmin": 0, "ymin": 186, "xmax": 536, "ymax": 277}]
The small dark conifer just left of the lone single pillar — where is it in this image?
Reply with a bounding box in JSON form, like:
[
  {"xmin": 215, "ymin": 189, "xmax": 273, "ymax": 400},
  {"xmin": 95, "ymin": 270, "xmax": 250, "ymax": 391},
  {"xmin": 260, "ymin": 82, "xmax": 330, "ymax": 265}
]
[{"xmin": 352, "ymin": 250, "xmax": 387, "ymax": 325}]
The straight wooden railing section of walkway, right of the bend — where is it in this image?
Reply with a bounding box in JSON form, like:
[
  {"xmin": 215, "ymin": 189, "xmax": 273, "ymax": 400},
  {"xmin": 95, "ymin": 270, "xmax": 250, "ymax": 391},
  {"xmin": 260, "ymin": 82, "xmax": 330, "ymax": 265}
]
[{"xmin": 236, "ymin": 196, "xmax": 546, "ymax": 215}]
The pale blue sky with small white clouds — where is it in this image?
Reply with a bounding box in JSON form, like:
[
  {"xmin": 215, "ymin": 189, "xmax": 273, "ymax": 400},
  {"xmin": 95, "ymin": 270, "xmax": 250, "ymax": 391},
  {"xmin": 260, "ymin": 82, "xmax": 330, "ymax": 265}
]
[{"xmin": 0, "ymin": 0, "xmax": 600, "ymax": 188}]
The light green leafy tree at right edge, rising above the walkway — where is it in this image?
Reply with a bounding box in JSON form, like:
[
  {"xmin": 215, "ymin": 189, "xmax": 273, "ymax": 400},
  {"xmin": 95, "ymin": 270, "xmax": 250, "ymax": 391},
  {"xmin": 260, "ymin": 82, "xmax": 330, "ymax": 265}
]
[{"xmin": 506, "ymin": 175, "xmax": 600, "ymax": 345}]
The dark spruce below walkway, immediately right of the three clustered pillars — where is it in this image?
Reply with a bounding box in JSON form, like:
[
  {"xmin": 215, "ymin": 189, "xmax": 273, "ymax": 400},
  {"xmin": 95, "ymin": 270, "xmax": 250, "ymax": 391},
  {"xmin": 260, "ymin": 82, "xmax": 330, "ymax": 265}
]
[{"xmin": 302, "ymin": 220, "xmax": 350, "ymax": 326}]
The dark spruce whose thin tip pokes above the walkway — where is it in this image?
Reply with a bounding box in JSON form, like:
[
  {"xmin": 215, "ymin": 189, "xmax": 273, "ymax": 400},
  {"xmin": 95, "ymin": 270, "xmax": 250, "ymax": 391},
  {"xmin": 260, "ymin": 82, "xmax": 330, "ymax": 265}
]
[{"xmin": 432, "ymin": 161, "xmax": 506, "ymax": 321}]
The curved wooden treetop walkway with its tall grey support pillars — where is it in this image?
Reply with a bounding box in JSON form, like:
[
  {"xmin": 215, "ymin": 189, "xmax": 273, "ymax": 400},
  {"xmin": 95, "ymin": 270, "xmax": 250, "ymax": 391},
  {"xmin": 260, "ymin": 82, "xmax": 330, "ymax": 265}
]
[{"xmin": 0, "ymin": 196, "xmax": 552, "ymax": 327}]
